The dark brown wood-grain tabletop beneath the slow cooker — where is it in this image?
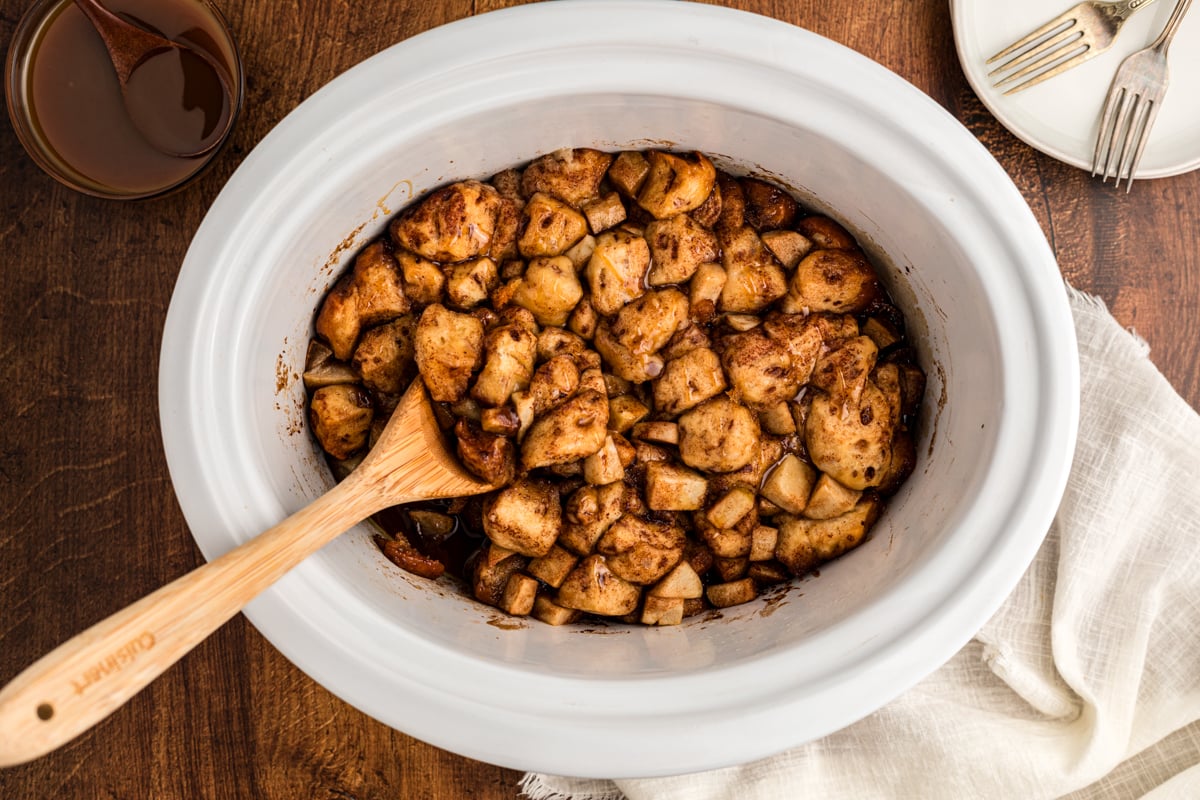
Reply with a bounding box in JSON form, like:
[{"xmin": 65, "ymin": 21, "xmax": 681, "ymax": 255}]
[{"xmin": 0, "ymin": 0, "xmax": 1200, "ymax": 800}]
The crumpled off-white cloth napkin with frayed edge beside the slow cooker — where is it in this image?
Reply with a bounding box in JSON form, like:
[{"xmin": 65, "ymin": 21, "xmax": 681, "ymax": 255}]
[{"xmin": 521, "ymin": 290, "xmax": 1200, "ymax": 800}]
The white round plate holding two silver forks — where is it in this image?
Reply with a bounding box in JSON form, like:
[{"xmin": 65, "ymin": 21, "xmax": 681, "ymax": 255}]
[{"xmin": 950, "ymin": 0, "xmax": 1200, "ymax": 179}]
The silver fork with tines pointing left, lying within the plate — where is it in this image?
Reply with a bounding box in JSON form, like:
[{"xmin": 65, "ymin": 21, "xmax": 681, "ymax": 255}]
[{"xmin": 988, "ymin": 0, "xmax": 1154, "ymax": 95}]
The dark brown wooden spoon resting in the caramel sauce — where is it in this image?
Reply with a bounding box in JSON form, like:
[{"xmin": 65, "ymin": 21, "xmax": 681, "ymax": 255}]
[{"xmin": 74, "ymin": 0, "xmax": 233, "ymax": 158}]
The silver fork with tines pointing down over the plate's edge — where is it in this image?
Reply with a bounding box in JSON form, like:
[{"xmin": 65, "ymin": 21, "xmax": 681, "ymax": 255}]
[{"xmin": 1092, "ymin": 0, "xmax": 1192, "ymax": 192}]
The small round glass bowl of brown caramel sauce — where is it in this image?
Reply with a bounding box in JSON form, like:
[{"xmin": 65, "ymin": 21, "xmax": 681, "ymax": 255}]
[{"xmin": 5, "ymin": 0, "xmax": 245, "ymax": 199}]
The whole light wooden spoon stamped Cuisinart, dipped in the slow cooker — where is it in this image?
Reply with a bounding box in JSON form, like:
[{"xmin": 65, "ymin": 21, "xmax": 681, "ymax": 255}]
[{"xmin": 0, "ymin": 380, "xmax": 494, "ymax": 766}]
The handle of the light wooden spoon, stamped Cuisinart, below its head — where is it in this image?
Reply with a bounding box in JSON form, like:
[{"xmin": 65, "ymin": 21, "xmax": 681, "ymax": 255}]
[{"xmin": 0, "ymin": 480, "xmax": 378, "ymax": 766}]
